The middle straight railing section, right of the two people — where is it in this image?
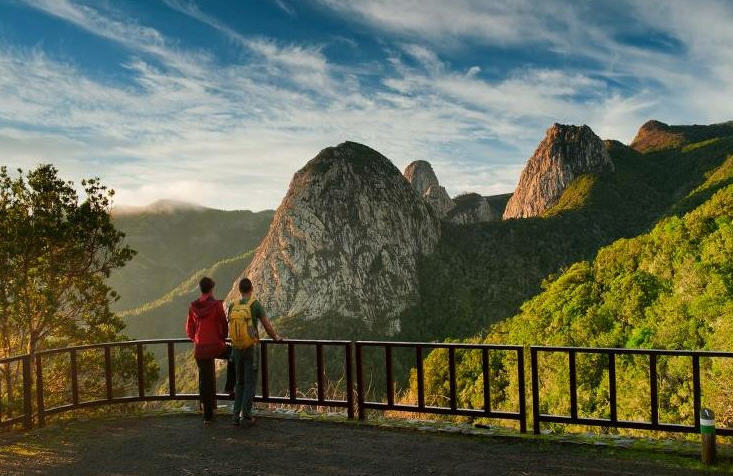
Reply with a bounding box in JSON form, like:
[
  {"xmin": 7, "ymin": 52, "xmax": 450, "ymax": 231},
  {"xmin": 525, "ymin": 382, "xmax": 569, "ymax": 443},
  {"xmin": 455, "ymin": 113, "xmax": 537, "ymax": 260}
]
[{"xmin": 355, "ymin": 341, "xmax": 527, "ymax": 433}]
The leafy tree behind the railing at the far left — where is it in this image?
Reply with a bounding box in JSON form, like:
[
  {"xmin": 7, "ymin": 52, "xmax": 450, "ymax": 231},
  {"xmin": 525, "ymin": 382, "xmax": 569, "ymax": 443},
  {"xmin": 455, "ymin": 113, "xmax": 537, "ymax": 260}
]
[{"xmin": 0, "ymin": 164, "xmax": 135, "ymax": 357}]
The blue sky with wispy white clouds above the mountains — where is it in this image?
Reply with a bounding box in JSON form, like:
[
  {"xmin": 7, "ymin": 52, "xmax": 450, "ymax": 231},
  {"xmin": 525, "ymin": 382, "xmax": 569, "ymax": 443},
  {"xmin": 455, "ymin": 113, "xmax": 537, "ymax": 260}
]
[{"xmin": 0, "ymin": 0, "xmax": 733, "ymax": 210}]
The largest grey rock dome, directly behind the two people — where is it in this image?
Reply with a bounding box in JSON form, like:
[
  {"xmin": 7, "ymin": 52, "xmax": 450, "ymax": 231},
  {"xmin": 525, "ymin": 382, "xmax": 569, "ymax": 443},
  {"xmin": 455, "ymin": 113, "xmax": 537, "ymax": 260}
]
[{"xmin": 228, "ymin": 142, "xmax": 440, "ymax": 332}]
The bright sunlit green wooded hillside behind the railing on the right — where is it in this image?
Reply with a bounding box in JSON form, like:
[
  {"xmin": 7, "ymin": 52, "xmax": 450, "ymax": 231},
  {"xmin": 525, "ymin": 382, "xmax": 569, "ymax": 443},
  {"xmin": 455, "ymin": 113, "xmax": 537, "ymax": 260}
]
[{"xmin": 413, "ymin": 143, "xmax": 733, "ymax": 430}]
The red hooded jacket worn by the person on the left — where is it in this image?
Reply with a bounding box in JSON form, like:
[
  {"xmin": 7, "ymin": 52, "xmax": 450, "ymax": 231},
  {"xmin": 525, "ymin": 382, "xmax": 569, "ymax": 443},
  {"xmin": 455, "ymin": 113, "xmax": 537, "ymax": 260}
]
[{"xmin": 186, "ymin": 294, "xmax": 229, "ymax": 359}]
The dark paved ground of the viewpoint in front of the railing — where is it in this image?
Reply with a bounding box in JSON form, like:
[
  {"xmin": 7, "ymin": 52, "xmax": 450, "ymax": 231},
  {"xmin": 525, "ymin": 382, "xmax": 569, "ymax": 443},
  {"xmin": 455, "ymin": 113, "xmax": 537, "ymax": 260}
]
[{"xmin": 0, "ymin": 415, "xmax": 720, "ymax": 475}]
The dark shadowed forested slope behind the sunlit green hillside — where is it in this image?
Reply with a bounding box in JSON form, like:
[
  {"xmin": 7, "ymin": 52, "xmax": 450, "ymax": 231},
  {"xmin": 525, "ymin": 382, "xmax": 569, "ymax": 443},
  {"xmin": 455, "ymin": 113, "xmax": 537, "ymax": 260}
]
[{"xmin": 399, "ymin": 120, "xmax": 733, "ymax": 340}]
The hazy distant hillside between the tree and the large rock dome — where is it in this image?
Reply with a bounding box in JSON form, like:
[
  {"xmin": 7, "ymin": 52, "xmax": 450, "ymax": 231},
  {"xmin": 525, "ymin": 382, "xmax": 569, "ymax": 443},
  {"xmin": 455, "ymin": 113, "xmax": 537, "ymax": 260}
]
[{"xmin": 110, "ymin": 201, "xmax": 274, "ymax": 311}]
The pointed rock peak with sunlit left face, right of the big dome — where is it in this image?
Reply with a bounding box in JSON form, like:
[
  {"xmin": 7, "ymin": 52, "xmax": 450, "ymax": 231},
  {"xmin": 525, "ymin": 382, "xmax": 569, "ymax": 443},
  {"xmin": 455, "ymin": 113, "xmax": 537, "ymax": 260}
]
[{"xmin": 504, "ymin": 124, "xmax": 614, "ymax": 219}]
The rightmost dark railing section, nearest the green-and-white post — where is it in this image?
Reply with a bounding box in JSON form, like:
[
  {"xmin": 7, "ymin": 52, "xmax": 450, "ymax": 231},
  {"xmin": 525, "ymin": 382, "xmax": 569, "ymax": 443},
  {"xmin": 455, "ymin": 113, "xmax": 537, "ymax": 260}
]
[{"xmin": 530, "ymin": 346, "xmax": 733, "ymax": 435}]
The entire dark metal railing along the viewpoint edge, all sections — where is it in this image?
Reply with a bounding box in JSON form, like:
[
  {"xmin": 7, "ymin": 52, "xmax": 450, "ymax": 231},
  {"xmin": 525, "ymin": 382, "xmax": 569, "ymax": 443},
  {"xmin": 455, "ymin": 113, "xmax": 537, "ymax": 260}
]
[{"xmin": 0, "ymin": 339, "xmax": 733, "ymax": 435}]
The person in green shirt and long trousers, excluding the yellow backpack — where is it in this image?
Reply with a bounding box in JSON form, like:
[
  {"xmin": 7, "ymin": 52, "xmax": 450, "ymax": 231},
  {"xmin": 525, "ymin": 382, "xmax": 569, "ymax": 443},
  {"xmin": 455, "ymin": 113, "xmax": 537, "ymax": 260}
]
[{"xmin": 227, "ymin": 278, "xmax": 282, "ymax": 425}]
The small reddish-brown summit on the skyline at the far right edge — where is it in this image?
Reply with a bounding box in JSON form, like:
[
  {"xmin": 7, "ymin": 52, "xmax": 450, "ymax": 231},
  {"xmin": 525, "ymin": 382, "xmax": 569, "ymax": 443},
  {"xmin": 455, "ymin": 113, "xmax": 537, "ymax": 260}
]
[{"xmin": 629, "ymin": 120, "xmax": 733, "ymax": 153}]
